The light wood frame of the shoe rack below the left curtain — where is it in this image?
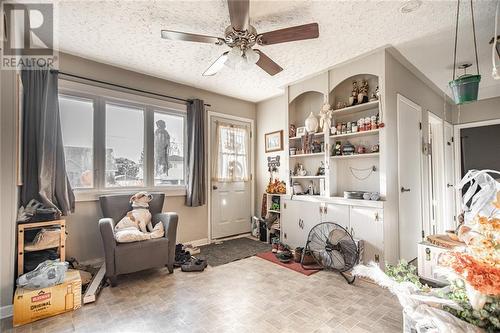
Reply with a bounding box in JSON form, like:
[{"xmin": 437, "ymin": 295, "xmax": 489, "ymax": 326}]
[{"xmin": 17, "ymin": 220, "xmax": 66, "ymax": 277}]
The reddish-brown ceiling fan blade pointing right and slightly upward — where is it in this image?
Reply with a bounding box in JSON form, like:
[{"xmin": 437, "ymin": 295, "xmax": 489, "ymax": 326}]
[{"xmin": 257, "ymin": 23, "xmax": 319, "ymax": 45}]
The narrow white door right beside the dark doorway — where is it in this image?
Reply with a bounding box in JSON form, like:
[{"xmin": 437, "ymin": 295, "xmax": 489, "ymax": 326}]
[{"xmin": 444, "ymin": 122, "xmax": 455, "ymax": 230}]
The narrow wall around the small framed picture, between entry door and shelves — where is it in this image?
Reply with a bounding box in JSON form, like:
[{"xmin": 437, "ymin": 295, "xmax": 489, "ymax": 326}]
[{"xmin": 255, "ymin": 94, "xmax": 288, "ymax": 216}]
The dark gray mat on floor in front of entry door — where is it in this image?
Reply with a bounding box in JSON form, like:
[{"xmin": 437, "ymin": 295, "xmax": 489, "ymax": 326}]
[{"xmin": 195, "ymin": 237, "xmax": 271, "ymax": 266}]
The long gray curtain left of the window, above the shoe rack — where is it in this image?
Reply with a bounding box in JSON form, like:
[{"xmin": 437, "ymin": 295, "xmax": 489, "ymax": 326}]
[{"xmin": 21, "ymin": 69, "xmax": 75, "ymax": 215}]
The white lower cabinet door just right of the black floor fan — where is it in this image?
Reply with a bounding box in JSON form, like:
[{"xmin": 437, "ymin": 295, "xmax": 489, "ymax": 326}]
[{"xmin": 350, "ymin": 206, "xmax": 384, "ymax": 265}]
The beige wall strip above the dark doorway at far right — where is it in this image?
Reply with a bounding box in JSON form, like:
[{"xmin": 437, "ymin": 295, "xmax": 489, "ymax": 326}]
[{"xmin": 453, "ymin": 97, "xmax": 500, "ymax": 124}]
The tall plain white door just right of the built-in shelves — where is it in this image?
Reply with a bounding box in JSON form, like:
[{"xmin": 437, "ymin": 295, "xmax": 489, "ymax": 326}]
[{"xmin": 398, "ymin": 94, "xmax": 423, "ymax": 261}]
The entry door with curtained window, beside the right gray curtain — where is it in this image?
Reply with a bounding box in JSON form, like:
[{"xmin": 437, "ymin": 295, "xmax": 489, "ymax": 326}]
[{"xmin": 210, "ymin": 116, "xmax": 253, "ymax": 239}]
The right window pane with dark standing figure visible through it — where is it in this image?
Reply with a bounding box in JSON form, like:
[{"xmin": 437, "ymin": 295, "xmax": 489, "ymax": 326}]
[{"xmin": 154, "ymin": 112, "xmax": 184, "ymax": 186}]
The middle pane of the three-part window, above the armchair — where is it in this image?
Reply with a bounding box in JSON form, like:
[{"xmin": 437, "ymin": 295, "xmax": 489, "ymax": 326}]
[{"xmin": 105, "ymin": 103, "xmax": 144, "ymax": 187}]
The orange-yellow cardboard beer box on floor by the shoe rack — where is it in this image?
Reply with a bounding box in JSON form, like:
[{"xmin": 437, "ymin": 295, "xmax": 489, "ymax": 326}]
[{"xmin": 13, "ymin": 270, "xmax": 82, "ymax": 326}]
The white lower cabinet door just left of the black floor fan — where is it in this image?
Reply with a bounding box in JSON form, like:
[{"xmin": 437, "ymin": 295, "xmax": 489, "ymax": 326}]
[{"xmin": 281, "ymin": 200, "xmax": 321, "ymax": 248}]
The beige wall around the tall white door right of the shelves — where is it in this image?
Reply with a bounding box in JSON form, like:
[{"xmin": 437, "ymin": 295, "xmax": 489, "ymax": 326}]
[{"xmin": 384, "ymin": 52, "xmax": 452, "ymax": 260}]
